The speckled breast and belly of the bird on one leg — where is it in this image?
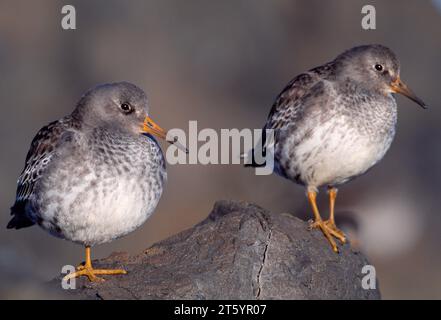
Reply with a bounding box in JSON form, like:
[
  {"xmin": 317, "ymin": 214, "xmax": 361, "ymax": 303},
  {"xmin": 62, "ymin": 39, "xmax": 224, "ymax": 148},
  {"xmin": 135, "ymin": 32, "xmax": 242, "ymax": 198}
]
[{"xmin": 32, "ymin": 131, "xmax": 166, "ymax": 245}]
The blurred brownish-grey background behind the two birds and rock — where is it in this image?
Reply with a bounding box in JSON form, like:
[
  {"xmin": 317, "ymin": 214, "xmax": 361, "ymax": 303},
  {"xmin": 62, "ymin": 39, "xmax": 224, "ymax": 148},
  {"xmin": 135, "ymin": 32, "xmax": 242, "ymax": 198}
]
[{"xmin": 0, "ymin": 0, "xmax": 441, "ymax": 299}]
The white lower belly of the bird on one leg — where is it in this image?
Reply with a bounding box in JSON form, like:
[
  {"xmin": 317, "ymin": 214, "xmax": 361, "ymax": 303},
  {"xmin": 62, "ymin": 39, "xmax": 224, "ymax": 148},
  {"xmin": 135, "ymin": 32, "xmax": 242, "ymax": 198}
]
[{"xmin": 36, "ymin": 173, "xmax": 162, "ymax": 246}]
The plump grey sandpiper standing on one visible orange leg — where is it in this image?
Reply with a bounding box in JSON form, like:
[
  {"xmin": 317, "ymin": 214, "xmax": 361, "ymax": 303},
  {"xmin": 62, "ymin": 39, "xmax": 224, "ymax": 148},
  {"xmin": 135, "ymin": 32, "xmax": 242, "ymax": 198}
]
[{"xmin": 7, "ymin": 82, "xmax": 183, "ymax": 281}]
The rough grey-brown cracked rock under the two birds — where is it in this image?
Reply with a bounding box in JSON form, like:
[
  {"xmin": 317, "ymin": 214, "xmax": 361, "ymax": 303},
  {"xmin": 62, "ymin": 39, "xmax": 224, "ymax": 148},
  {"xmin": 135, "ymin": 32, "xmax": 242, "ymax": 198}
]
[{"xmin": 51, "ymin": 201, "xmax": 380, "ymax": 299}]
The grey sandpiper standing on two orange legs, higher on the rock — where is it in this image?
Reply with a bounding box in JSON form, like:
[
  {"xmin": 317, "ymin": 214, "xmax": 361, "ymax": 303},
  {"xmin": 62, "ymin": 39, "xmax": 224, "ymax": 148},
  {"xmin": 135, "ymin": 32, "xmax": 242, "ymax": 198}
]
[{"xmin": 246, "ymin": 45, "xmax": 426, "ymax": 252}]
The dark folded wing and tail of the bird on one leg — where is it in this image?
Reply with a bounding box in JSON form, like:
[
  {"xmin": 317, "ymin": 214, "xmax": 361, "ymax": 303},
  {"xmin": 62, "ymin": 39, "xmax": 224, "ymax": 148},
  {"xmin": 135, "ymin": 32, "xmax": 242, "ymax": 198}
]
[{"xmin": 7, "ymin": 119, "xmax": 72, "ymax": 229}]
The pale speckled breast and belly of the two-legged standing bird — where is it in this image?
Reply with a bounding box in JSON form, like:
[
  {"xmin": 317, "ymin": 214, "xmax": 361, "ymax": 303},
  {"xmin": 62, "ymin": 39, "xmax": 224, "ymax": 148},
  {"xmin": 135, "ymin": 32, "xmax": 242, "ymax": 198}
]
[{"xmin": 276, "ymin": 92, "xmax": 397, "ymax": 188}]
